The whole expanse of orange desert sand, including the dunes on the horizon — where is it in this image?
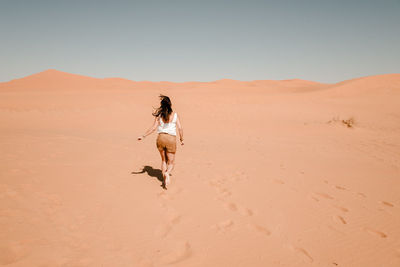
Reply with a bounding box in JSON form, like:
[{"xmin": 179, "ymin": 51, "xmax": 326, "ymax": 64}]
[{"xmin": 0, "ymin": 70, "xmax": 400, "ymax": 267}]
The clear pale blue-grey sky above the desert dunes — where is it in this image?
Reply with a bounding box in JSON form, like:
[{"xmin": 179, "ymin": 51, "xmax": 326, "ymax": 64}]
[{"xmin": 0, "ymin": 0, "xmax": 400, "ymax": 82}]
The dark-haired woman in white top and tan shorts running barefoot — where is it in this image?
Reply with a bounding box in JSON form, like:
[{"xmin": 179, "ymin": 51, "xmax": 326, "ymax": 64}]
[{"xmin": 138, "ymin": 95, "xmax": 183, "ymax": 188}]
